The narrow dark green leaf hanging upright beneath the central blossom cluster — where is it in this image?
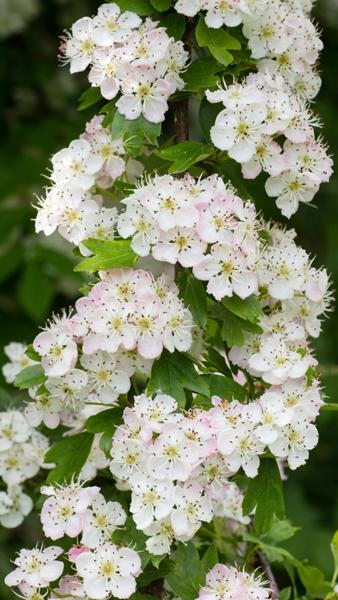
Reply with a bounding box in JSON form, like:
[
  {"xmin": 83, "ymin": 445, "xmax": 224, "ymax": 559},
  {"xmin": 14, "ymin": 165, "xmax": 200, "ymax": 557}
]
[{"xmin": 178, "ymin": 270, "xmax": 208, "ymax": 327}]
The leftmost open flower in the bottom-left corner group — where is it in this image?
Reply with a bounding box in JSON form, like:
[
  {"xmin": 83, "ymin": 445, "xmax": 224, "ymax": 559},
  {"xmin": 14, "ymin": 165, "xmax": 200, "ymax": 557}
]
[{"xmin": 5, "ymin": 546, "xmax": 63, "ymax": 588}]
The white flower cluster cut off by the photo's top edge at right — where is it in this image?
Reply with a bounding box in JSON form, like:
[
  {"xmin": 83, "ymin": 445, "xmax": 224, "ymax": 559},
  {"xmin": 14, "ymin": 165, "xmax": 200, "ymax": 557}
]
[{"xmin": 175, "ymin": 0, "xmax": 323, "ymax": 100}]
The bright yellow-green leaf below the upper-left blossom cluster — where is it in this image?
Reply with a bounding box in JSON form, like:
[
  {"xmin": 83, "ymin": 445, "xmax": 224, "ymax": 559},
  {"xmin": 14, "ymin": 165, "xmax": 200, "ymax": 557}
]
[{"xmin": 74, "ymin": 238, "xmax": 138, "ymax": 273}]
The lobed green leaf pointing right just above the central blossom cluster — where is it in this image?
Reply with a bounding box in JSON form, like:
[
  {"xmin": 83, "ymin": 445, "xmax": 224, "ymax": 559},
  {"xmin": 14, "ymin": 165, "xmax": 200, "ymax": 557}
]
[{"xmin": 155, "ymin": 142, "xmax": 214, "ymax": 173}]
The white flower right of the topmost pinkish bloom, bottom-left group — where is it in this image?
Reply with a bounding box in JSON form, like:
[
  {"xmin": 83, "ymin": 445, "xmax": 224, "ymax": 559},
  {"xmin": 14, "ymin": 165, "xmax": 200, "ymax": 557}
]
[{"xmin": 81, "ymin": 494, "xmax": 127, "ymax": 548}]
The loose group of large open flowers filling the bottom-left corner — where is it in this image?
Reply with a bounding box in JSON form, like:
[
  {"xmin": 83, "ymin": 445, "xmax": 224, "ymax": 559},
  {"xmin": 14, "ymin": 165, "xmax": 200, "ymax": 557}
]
[{"xmin": 5, "ymin": 482, "xmax": 141, "ymax": 600}]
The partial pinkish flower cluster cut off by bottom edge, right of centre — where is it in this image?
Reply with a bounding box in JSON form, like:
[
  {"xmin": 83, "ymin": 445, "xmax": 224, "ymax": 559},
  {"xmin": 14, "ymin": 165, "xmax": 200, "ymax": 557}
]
[{"xmin": 198, "ymin": 564, "xmax": 271, "ymax": 600}]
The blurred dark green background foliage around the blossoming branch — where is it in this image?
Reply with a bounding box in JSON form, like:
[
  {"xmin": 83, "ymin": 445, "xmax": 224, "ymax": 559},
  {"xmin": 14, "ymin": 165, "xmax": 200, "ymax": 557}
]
[{"xmin": 0, "ymin": 0, "xmax": 338, "ymax": 599}]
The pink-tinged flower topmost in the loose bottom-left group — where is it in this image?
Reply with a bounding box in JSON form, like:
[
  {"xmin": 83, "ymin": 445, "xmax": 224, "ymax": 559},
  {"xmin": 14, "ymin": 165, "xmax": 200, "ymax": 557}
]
[{"xmin": 41, "ymin": 483, "xmax": 100, "ymax": 540}]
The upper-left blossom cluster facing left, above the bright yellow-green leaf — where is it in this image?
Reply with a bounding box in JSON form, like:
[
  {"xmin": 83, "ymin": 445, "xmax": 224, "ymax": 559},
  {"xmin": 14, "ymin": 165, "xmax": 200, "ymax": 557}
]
[{"xmin": 35, "ymin": 115, "xmax": 142, "ymax": 248}]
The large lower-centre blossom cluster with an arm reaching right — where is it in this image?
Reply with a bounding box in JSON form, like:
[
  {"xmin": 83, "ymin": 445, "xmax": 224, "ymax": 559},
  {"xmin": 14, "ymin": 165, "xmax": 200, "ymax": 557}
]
[{"xmin": 110, "ymin": 378, "xmax": 321, "ymax": 555}]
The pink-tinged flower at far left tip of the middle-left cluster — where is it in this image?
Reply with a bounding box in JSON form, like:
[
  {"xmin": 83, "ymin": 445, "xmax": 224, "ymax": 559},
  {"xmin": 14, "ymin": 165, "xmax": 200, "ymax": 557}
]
[{"xmin": 33, "ymin": 315, "xmax": 77, "ymax": 377}]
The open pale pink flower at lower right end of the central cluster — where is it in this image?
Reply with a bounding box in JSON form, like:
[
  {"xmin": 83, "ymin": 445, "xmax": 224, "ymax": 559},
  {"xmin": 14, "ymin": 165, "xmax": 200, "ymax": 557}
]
[{"xmin": 193, "ymin": 244, "xmax": 257, "ymax": 300}]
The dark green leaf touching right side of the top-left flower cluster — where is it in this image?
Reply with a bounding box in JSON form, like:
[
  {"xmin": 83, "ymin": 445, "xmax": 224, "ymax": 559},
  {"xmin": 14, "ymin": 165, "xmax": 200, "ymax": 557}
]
[{"xmin": 182, "ymin": 56, "xmax": 223, "ymax": 92}]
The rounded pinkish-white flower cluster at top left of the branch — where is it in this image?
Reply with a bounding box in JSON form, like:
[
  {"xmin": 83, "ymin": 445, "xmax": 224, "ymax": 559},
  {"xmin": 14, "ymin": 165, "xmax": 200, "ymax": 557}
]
[{"xmin": 61, "ymin": 3, "xmax": 188, "ymax": 123}]
